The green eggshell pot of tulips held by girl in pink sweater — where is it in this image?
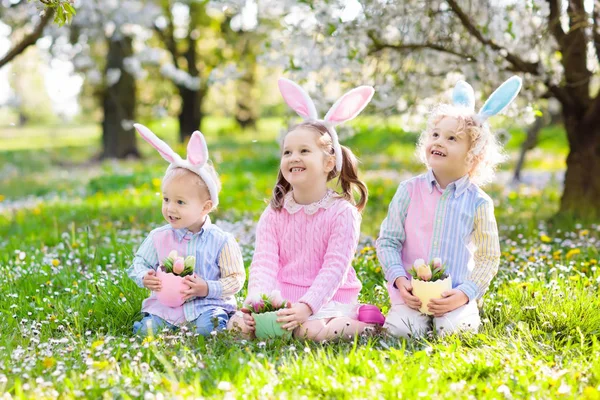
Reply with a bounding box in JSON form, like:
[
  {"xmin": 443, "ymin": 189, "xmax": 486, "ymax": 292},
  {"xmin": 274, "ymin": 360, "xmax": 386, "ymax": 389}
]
[{"xmin": 246, "ymin": 290, "xmax": 292, "ymax": 339}]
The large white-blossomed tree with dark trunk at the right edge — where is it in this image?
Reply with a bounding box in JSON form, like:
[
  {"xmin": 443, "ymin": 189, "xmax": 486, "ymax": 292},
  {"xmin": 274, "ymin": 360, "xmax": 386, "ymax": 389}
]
[{"xmin": 266, "ymin": 0, "xmax": 600, "ymax": 218}]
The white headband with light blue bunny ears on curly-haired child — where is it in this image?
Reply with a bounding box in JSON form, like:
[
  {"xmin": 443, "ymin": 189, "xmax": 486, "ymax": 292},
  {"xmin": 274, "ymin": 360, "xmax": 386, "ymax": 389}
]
[{"xmin": 452, "ymin": 76, "xmax": 522, "ymax": 154}]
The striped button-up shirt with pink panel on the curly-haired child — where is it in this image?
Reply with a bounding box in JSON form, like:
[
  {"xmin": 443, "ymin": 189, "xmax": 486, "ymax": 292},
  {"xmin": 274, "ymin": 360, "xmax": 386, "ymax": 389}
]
[{"xmin": 377, "ymin": 170, "xmax": 500, "ymax": 304}]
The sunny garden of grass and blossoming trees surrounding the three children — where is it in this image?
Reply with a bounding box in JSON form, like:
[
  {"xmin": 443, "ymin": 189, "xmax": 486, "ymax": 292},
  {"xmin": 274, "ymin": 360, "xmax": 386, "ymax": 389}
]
[{"xmin": 0, "ymin": 0, "xmax": 600, "ymax": 399}]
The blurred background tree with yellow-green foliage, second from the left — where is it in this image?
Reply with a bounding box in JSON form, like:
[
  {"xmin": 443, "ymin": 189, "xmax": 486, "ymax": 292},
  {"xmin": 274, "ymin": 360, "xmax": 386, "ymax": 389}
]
[{"xmin": 154, "ymin": 1, "xmax": 268, "ymax": 141}]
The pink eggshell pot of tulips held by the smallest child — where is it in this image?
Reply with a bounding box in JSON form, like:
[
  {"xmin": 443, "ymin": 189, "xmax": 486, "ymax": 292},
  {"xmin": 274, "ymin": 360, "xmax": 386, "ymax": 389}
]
[{"xmin": 156, "ymin": 250, "xmax": 196, "ymax": 307}]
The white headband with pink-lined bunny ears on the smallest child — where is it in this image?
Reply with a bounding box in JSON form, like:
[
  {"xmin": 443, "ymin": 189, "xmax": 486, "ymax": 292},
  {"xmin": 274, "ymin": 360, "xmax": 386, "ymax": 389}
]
[{"xmin": 133, "ymin": 124, "xmax": 219, "ymax": 208}]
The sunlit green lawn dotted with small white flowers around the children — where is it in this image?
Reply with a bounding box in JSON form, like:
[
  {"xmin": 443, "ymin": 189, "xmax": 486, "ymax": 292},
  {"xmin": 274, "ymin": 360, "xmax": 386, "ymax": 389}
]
[{"xmin": 0, "ymin": 120, "xmax": 600, "ymax": 399}]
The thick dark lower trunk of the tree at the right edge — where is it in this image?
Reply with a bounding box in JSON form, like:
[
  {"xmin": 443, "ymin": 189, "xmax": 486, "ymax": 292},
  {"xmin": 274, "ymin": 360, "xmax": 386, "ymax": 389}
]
[{"xmin": 560, "ymin": 110, "xmax": 600, "ymax": 222}]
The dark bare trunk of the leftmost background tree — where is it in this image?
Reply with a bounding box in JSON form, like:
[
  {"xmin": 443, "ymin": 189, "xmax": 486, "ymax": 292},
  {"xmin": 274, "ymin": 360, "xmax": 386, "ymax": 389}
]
[{"xmin": 101, "ymin": 37, "xmax": 140, "ymax": 158}]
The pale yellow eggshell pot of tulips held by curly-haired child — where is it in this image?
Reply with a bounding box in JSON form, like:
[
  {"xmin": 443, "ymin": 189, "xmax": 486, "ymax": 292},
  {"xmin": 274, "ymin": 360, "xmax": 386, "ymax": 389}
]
[{"xmin": 410, "ymin": 258, "xmax": 452, "ymax": 315}]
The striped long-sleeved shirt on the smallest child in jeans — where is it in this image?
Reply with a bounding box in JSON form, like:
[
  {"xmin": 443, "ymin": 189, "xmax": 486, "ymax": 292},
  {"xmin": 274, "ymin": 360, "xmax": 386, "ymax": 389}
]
[{"xmin": 127, "ymin": 216, "xmax": 246, "ymax": 324}]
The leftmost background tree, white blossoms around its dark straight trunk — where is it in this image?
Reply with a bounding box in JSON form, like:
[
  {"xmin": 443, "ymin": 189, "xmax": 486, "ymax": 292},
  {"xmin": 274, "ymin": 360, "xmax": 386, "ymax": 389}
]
[{"xmin": 52, "ymin": 0, "xmax": 160, "ymax": 158}]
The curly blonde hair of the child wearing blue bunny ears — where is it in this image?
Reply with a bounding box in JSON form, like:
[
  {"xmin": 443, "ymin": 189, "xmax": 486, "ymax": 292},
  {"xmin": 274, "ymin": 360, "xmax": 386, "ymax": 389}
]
[{"xmin": 416, "ymin": 104, "xmax": 507, "ymax": 186}]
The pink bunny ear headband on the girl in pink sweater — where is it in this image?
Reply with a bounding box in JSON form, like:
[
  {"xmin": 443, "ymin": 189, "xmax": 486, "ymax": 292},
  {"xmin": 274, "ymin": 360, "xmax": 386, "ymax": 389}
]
[{"xmin": 277, "ymin": 78, "xmax": 375, "ymax": 171}]
